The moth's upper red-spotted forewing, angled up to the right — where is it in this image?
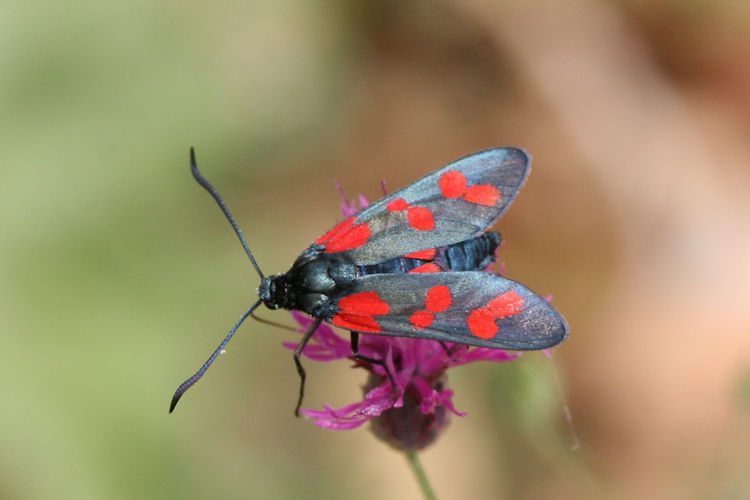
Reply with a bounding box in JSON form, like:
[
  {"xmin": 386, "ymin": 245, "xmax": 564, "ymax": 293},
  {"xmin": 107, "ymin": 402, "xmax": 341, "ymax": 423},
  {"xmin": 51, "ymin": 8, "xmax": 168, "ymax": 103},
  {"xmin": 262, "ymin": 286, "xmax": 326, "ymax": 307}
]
[{"xmin": 316, "ymin": 148, "xmax": 531, "ymax": 265}]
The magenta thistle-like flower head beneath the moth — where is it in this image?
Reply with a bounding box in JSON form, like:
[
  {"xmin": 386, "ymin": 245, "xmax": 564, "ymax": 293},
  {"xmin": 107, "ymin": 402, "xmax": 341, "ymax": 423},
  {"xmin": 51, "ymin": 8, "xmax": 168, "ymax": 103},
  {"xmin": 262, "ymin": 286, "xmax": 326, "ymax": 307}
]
[{"xmin": 283, "ymin": 184, "xmax": 520, "ymax": 450}]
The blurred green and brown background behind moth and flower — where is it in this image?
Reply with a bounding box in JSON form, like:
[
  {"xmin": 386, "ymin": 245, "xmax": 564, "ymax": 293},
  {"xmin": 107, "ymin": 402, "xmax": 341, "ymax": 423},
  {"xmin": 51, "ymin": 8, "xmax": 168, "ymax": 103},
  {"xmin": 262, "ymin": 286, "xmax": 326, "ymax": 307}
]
[{"xmin": 0, "ymin": 0, "xmax": 750, "ymax": 499}]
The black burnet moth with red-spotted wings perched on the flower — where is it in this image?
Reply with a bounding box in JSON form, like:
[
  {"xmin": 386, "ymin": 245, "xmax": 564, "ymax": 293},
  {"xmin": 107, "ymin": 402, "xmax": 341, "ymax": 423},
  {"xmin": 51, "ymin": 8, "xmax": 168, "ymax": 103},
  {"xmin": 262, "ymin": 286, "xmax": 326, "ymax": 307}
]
[{"xmin": 169, "ymin": 148, "xmax": 568, "ymax": 415}]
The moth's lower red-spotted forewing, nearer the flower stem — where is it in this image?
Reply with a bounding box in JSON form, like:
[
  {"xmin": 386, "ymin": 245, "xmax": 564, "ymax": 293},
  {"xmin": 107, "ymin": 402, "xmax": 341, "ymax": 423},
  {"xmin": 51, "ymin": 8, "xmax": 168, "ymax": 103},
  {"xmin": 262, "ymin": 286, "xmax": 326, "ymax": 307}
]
[{"xmin": 330, "ymin": 271, "xmax": 568, "ymax": 350}]
